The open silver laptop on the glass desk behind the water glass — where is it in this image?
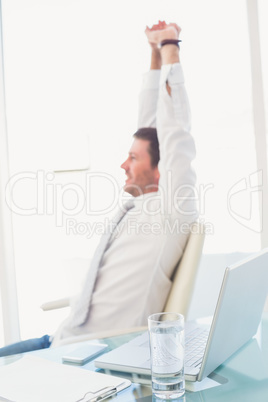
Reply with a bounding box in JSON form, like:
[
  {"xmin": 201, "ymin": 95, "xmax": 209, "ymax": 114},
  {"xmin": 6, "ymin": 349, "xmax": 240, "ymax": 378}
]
[{"xmin": 94, "ymin": 248, "xmax": 268, "ymax": 381}]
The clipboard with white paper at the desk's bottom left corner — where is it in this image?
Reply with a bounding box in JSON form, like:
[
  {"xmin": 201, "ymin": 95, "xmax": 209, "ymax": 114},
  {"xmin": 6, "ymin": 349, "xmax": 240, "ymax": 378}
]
[{"xmin": 0, "ymin": 355, "xmax": 131, "ymax": 402}]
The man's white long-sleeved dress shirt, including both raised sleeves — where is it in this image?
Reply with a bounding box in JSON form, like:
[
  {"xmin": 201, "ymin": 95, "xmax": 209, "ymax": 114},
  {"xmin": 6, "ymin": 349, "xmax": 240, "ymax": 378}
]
[{"xmin": 53, "ymin": 63, "xmax": 197, "ymax": 345}]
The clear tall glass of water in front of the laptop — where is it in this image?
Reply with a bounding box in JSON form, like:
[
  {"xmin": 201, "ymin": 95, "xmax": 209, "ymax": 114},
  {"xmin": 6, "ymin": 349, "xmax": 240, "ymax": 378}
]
[{"xmin": 148, "ymin": 313, "xmax": 185, "ymax": 399}]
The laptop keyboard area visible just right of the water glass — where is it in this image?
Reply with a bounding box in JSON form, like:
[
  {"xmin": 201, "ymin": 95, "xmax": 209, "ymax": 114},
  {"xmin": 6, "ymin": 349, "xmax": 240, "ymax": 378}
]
[{"xmin": 185, "ymin": 328, "xmax": 209, "ymax": 367}]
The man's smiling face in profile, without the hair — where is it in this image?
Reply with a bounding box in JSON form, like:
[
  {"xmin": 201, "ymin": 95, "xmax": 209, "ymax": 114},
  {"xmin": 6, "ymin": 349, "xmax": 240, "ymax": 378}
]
[{"xmin": 121, "ymin": 138, "xmax": 159, "ymax": 197}]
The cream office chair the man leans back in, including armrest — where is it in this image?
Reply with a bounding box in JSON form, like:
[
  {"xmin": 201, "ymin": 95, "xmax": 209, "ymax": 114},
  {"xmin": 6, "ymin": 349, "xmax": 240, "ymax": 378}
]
[{"xmin": 41, "ymin": 222, "xmax": 205, "ymax": 345}]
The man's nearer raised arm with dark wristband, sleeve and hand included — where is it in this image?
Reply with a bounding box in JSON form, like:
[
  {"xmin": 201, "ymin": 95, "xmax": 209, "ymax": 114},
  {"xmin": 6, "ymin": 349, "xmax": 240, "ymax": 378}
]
[{"xmin": 147, "ymin": 24, "xmax": 197, "ymax": 221}]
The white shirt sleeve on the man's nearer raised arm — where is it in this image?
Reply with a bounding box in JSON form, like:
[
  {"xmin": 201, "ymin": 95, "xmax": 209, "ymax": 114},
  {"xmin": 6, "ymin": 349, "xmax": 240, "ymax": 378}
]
[{"xmin": 156, "ymin": 63, "xmax": 197, "ymax": 222}]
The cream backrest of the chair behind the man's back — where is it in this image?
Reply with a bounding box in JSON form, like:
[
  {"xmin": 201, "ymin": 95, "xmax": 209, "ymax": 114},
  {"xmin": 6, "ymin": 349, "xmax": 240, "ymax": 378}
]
[{"xmin": 164, "ymin": 222, "xmax": 205, "ymax": 319}]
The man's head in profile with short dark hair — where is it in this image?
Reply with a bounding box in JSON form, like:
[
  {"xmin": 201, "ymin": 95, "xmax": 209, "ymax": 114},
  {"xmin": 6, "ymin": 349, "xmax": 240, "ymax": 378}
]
[{"xmin": 121, "ymin": 127, "xmax": 160, "ymax": 197}]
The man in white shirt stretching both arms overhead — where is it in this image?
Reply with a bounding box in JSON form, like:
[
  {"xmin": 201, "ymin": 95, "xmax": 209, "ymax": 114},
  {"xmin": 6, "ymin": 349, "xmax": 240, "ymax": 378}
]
[{"xmin": 0, "ymin": 21, "xmax": 197, "ymax": 356}]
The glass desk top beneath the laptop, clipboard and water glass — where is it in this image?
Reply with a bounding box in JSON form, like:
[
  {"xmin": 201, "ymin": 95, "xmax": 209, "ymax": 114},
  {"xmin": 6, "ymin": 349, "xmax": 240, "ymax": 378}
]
[{"xmin": 0, "ymin": 313, "xmax": 268, "ymax": 402}]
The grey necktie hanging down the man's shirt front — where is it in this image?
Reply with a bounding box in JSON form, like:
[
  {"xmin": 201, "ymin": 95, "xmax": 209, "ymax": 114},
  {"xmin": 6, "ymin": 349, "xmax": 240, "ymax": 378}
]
[{"xmin": 72, "ymin": 199, "xmax": 134, "ymax": 328}]
